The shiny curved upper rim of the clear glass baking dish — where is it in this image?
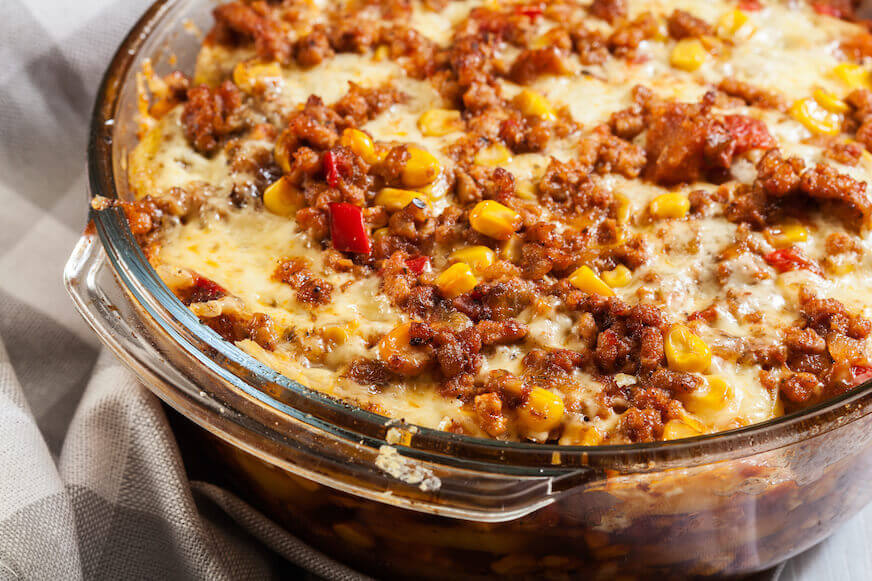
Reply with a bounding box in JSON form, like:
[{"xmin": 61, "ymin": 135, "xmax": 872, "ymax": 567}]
[{"xmin": 88, "ymin": 0, "xmax": 872, "ymax": 474}]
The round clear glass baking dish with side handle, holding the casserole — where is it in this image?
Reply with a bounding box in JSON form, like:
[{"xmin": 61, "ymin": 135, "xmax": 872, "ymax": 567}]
[{"xmin": 64, "ymin": 0, "xmax": 872, "ymax": 579}]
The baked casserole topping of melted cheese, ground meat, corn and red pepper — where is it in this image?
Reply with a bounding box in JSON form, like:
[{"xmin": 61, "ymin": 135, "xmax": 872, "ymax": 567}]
[{"xmin": 122, "ymin": 0, "xmax": 872, "ymax": 445}]
